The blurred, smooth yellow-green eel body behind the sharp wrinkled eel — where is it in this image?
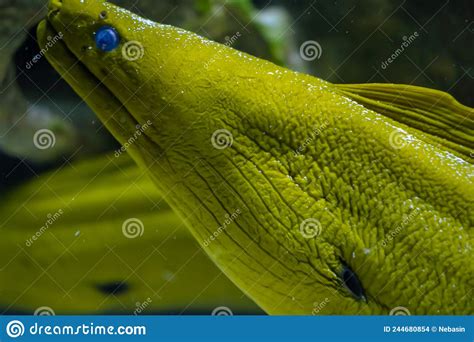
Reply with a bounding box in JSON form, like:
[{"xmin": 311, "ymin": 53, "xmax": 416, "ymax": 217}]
[{"xmin": 0, "ymin": 155, "xmax": 260, "ymax": 314}]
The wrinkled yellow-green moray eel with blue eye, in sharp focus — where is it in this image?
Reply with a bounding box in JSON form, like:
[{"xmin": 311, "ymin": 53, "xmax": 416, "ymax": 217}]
[{"xmin": 38, "ymin": 0, "xmax": 474, "ymax": 314}]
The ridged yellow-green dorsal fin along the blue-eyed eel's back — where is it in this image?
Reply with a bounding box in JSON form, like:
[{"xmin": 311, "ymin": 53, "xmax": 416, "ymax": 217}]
[{"xmin": 336, "ymin": 83, "xmax": 474, "ymax": 162}]
